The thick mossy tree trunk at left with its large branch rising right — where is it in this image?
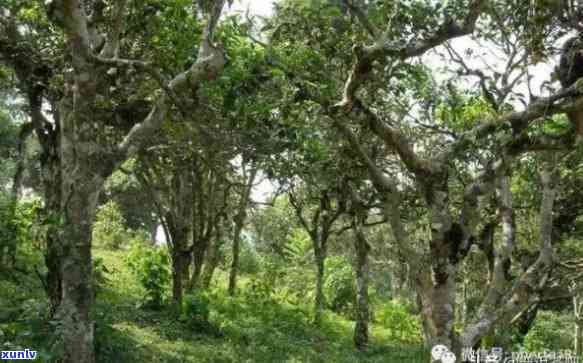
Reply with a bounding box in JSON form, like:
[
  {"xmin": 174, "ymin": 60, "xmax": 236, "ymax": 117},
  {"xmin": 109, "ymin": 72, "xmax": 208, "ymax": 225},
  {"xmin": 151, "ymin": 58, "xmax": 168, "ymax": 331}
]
[{"xmin": 10, "ymin": 0, "xmax": 224, "ymax": 363}]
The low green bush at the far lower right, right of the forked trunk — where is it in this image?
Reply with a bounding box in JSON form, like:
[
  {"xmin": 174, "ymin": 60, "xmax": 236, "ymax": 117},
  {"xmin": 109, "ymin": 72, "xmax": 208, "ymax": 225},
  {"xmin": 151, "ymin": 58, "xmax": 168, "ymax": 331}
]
[{"xmin": 523, "ymin": 311, "xmax": 573, "ymax": 352}]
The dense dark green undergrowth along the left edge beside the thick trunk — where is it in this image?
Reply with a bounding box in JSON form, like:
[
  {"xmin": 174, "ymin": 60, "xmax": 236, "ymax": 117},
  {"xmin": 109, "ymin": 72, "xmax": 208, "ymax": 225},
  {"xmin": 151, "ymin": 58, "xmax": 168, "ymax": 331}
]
[{"xmin": 0, "ymin": 192, "xmax": 58, "ymax": 361}]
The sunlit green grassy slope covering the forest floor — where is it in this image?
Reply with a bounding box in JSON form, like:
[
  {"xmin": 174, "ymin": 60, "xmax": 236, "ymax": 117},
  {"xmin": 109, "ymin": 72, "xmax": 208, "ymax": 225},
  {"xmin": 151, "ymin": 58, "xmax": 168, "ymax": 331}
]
[{"xmin": 95, "ymin": 250, "xmax": 425, "ymax": 363}]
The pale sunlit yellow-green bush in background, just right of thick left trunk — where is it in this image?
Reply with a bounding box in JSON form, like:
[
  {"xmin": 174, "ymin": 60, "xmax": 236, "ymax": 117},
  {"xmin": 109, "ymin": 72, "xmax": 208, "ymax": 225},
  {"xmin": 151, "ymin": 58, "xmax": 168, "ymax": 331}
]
[{"xmin": 93, "ymin": 201, "xmax": 130, "ymax": 249}]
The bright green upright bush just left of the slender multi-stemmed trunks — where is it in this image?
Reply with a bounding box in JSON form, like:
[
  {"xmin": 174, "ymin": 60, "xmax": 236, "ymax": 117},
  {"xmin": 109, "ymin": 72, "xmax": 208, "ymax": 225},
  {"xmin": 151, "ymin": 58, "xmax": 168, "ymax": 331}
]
[{"xmin": 126, "ymin": 243, "xmax": 171, "ymax": 309}]
